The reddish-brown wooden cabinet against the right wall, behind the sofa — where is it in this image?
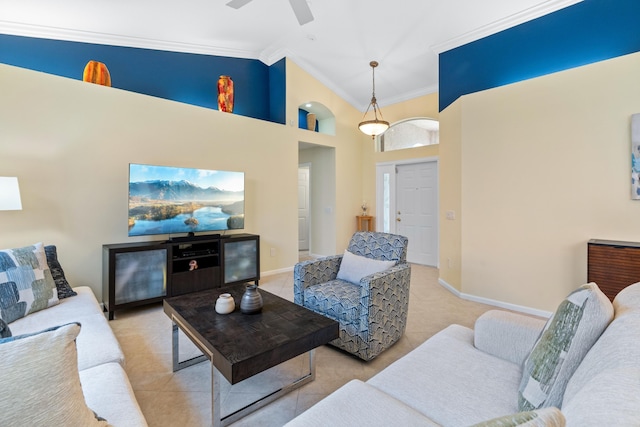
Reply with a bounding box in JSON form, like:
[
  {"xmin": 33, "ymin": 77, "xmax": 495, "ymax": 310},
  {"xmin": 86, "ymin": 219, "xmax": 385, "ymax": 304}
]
[{"xmin": 587, "ymin": 239, "xmax": 640, "ymax": 301}]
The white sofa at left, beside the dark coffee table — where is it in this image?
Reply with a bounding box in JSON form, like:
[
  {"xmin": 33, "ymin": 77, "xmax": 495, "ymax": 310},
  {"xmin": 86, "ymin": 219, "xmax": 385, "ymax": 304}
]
[{"xmin": 9, "ymin": 286, "xmax": 147, "ymax": 427}]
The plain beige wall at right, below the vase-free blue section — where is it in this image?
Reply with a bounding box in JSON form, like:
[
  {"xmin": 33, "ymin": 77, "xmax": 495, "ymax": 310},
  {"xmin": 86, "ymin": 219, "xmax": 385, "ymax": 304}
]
[{"xmin": 440, "ymin": 50, "xmax": 640, "ymax": 311}]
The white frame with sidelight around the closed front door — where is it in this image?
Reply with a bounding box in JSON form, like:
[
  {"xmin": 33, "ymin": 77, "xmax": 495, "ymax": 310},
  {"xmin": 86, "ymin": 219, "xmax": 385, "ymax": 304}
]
[{"xmin": 376, "ymin": 156, "xmax": 440, "ymax": 268}]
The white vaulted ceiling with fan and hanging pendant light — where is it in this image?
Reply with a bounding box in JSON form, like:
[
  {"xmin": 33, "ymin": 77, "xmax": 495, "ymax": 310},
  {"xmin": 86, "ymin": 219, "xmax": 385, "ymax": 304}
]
[{"xmin": 0, "ymin": 0, "xmax": 581, "ymax": 111}]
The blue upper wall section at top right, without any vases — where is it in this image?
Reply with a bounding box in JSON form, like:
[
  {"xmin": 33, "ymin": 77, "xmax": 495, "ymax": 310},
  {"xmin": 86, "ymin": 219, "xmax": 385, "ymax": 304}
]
[{"xmin": 439, "ymin": 0, "xmax": 640, "ymax": 111}]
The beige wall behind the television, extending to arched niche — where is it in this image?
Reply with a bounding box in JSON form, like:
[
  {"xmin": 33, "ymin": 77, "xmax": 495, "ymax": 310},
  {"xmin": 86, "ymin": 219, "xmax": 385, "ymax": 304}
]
[{"xmin": 0, "ymin": 62, "xmax": 362, "ymax": 298}]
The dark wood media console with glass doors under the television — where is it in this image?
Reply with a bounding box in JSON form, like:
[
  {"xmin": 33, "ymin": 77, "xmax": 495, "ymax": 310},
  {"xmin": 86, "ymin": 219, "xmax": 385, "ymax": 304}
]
[{"xmin": 102, "ymin": 233, "xmax": 260, "ymax": 320}]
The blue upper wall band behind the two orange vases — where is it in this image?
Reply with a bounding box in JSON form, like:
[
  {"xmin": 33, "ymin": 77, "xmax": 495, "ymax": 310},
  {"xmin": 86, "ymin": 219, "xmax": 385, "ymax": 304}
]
[{"xmin": 0, "ymin": 34, "xmax": 286, "ymax": 124}]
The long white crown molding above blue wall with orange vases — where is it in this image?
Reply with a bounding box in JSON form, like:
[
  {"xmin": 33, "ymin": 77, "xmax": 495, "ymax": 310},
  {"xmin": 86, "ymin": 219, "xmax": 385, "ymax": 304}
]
[{"xmin": 0, "ymin": 20, "xmax": 259, "ymax": 59}]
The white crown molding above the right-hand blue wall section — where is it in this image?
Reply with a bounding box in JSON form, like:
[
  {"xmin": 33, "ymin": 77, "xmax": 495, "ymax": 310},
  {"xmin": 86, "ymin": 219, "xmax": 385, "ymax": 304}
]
[{"xmin": 431, "ymin": 0, "xmax": 583, "ymax": 54}]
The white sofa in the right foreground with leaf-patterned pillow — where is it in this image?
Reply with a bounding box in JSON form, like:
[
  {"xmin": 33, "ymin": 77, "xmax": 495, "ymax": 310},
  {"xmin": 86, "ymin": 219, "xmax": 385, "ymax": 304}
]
[{"xmin": 287, "ymin": 283, "xmax": 640, "ymax": 427}]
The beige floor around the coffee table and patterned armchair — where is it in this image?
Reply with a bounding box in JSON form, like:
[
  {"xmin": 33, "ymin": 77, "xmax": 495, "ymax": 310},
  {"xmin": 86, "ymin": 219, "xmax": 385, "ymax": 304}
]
[{"xmin": 110, "ymin": 265, "xmax": 494, "ymax": 427}]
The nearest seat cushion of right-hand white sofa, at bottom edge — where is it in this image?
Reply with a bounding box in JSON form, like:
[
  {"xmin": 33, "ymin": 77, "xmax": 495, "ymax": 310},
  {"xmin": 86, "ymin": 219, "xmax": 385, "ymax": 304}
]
[{"xmin": 285, "ymin": 380, "xmax": 438, "ymax": 427}]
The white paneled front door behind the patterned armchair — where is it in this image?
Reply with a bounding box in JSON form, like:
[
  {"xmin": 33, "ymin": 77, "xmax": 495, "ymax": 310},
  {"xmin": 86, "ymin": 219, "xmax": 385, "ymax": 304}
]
[{"xmin": 395, "ymin": 161, "xmax": 438, "ymax": 266}]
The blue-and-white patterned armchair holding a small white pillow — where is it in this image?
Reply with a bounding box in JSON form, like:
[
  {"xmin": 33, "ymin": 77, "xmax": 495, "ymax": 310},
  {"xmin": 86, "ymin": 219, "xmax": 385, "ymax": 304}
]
[{"xmin": 293, "ymin": 231, "xmax": 411, "ymax": 360}]
